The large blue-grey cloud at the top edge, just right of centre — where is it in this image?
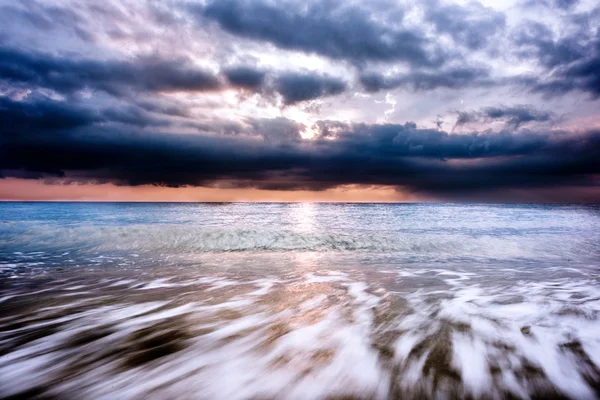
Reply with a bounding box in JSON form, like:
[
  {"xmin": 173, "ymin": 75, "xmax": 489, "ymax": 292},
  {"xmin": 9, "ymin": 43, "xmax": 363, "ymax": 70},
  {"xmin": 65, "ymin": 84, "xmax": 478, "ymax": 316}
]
[{"xmin": 197, "ymin": 0, "xmax": 444, "ymax": 66}]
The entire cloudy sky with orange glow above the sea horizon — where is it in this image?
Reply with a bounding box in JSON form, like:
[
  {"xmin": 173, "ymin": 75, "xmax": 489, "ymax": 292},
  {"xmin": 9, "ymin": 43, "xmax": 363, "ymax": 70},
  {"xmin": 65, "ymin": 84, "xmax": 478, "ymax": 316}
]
[{"xmin": 0, "ymin": 0, "xmax": 600, "ymax": 203}]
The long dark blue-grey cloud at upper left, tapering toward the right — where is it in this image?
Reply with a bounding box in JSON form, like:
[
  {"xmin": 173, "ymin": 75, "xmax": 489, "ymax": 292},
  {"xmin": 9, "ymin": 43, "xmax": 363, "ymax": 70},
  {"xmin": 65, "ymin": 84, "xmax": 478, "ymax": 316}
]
[{"xmin": 0, "ymin": 47, "xmax": 221, "ymax": 94}]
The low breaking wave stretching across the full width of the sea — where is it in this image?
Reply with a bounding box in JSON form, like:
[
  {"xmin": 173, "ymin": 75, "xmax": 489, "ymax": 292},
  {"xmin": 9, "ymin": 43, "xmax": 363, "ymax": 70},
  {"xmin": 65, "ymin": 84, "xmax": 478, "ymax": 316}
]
[{"xmin": 0, "ymin": 224, "xmax": 599, "ymax": 260}]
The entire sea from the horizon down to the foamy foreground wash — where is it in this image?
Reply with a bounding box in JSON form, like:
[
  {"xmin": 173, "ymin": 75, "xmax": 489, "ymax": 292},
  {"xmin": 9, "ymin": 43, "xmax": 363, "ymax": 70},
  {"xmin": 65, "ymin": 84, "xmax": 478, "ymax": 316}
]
[{"xmin": 0, "ymin": 203, "xmax": 600, "ymax": 399}]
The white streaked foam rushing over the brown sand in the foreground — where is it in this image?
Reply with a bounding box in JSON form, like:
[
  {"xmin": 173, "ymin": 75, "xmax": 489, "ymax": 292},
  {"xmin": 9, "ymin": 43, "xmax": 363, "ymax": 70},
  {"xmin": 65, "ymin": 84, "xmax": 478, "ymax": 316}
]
[{"xmin": 0, "ymin": 268, "xmax": 600, "ymax": 399}]
